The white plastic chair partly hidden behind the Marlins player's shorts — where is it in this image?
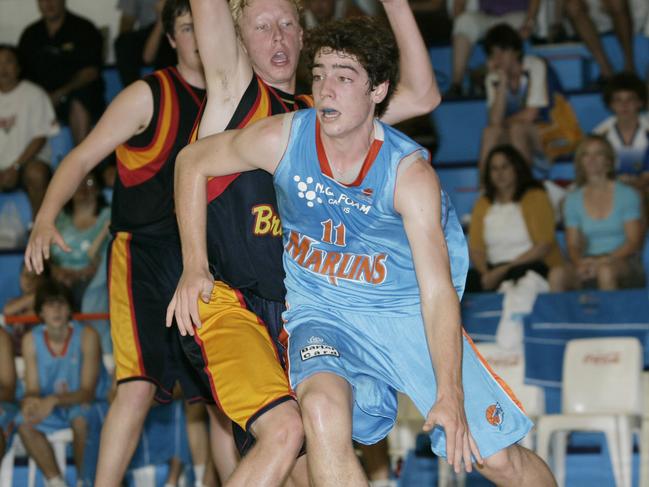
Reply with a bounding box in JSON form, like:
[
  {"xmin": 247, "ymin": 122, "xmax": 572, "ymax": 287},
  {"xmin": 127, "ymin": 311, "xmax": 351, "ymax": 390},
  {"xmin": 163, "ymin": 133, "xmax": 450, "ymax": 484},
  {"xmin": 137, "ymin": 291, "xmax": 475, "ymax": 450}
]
[{"xmin": 438, "ymin": 343, "xmax": 545, "ymax": 487}]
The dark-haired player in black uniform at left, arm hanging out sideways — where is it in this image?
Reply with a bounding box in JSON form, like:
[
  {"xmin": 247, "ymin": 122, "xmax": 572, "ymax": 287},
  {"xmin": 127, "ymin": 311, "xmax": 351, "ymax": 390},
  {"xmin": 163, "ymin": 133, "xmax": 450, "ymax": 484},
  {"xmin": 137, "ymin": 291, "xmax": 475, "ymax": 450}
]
[{"xmin": 25, "ymin": 0, "xmax": 234, "ymax": 486}]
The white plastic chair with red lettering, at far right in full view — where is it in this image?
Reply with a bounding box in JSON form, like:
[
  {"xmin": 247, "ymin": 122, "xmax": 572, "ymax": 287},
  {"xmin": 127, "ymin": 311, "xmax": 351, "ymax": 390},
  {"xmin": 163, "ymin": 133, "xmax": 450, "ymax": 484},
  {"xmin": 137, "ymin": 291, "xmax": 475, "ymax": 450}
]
[{"xmin": 537, "ymin": 337, "xmax": 643, "ymax": 487}]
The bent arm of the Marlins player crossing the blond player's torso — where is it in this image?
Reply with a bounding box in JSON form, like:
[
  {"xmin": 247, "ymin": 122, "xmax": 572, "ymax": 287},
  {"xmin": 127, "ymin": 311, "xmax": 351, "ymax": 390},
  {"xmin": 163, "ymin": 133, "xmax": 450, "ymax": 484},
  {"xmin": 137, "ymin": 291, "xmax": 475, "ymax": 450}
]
[{"xmin": 166, "ymin": 114, "xmax": 292, "ymax": 336}]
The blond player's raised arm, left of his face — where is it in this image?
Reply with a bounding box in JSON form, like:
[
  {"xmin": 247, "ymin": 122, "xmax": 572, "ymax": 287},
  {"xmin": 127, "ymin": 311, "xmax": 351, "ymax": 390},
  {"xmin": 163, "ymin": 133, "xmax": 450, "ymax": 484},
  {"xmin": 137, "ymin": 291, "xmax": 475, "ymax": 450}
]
[{"xmin": 190, "ymin": 0, "xmax": 252, "ymax": 138}]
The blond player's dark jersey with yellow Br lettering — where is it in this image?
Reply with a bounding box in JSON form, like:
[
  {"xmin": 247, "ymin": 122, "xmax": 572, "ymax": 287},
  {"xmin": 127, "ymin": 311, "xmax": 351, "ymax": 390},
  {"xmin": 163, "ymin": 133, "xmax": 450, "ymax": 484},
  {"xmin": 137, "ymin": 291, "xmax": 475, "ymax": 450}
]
[{"xmin": 207, "ymin": 75, "xmax": 313, "ymax": 302}]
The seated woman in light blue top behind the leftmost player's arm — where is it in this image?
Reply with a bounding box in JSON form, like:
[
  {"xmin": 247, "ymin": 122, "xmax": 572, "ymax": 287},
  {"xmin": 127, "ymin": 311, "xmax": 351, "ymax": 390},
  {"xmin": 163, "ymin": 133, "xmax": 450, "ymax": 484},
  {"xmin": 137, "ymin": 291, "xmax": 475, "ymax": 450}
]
[{"xmin": 50, "ymin": 172, "xmax": 110, "ymax": 310}]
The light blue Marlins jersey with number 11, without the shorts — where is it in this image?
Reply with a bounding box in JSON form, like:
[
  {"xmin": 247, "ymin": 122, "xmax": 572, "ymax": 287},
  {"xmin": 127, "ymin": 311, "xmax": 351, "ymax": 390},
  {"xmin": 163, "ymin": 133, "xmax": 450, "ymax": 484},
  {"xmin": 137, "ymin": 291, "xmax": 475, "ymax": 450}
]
[{"xmin": 274, "ymin": 110, "xmax": 469, "ymax": 316}]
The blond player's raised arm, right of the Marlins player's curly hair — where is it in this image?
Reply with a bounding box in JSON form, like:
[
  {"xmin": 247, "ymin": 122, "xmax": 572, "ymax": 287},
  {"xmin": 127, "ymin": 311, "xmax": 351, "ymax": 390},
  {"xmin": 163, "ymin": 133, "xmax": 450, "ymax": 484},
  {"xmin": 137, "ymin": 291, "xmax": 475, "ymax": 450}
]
[{"xmin": 381, "ymin": 0, "xmax": 441, "ymax": 124}]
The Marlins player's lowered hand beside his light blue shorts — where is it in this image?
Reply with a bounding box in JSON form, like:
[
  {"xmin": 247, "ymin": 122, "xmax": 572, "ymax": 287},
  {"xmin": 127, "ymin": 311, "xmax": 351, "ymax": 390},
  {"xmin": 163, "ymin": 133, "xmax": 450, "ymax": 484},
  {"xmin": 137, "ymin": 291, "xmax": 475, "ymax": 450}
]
[{"xmin": 423, "ymin": 393, "xmax": 483, "ymax": 473}]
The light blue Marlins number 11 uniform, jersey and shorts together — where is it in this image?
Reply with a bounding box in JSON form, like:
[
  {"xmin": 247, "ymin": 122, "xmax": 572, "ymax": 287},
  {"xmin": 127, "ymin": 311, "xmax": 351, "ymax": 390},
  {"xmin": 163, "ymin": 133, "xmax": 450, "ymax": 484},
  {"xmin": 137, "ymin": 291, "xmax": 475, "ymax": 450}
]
[{"xmin": 274, "ymin": 110, "xmax": 531, "ymax": 457}]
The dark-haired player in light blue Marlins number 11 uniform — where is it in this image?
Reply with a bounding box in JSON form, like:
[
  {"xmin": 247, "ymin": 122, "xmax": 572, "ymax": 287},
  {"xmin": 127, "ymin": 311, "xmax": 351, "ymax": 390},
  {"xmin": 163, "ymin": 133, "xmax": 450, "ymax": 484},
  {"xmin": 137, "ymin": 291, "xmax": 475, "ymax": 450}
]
[{"xmin": 176, "ymin": 19, "xmax": 555, "ymax": 486}]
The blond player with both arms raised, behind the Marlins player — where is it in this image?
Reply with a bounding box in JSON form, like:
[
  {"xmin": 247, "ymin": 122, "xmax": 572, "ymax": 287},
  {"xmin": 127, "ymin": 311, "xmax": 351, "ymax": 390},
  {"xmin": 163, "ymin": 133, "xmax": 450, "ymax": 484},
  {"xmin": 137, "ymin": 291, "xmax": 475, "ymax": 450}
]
[{"xmin": 167, "ymin": 0, "xmax": 439, "ymax": 485}]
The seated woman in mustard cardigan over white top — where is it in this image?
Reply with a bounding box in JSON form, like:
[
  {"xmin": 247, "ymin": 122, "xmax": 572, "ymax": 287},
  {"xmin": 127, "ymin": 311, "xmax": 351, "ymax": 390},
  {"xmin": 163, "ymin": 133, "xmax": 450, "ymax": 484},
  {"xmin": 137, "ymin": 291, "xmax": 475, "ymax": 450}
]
[{"xmin": 467, "ymin": 145, "xmax": 562, "ymax": 292}]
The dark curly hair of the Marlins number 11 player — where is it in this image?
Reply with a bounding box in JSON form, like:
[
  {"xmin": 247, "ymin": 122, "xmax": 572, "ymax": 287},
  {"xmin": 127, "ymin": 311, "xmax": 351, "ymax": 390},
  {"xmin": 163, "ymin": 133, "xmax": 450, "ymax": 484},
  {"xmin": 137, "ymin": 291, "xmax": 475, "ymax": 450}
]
[{"xmin": 304, "ymin": 17, "xmax": 399, "ymax": 117}]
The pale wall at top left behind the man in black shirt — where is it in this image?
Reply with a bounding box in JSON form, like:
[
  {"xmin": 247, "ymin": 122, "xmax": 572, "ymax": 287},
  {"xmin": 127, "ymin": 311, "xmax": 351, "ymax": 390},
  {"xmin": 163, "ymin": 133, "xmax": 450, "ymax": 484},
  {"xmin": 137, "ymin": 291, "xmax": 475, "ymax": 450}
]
[{"xmin": 0, "ymin": 0, "xmax": 119, "ymax": 63}]
